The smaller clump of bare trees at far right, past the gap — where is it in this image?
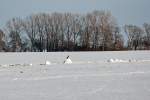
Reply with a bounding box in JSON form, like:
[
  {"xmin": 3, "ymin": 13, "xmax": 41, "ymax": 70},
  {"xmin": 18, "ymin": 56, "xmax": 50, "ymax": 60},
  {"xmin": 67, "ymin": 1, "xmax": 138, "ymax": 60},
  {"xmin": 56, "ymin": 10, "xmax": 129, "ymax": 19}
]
[{"xmin": 124, "ymin": 23, "xmax": 150, "ymax": 50}]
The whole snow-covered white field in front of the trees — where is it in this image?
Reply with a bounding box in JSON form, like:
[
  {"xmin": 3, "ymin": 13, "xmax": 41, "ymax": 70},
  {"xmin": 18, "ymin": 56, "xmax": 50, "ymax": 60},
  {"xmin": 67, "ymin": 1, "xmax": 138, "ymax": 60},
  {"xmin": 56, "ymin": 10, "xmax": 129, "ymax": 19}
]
[{"xmin": 0, "ymin": 51, "xmax": 150, "ymax": 100}]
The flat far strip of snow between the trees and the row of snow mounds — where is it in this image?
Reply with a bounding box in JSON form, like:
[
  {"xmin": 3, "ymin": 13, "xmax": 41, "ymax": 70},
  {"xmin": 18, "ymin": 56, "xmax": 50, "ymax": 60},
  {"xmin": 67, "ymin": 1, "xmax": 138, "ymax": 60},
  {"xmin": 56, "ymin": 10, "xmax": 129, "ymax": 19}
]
[{"xmin": 0, "ymin": 51, "xmax": 150, "ymax": 64}]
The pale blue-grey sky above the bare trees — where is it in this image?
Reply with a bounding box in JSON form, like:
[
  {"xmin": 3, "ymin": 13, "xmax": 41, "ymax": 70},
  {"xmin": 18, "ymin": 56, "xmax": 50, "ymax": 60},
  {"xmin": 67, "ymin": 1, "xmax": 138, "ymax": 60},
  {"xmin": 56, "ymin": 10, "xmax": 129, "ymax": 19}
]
[{"xmin": 0, "ymin": 0, "xmax": 150, "ymax": 28}]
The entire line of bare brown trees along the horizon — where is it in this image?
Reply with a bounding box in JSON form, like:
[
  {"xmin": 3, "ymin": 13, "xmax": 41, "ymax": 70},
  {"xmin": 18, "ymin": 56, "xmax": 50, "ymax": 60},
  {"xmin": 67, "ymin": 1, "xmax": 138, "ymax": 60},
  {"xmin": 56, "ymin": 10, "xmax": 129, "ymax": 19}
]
[{"xmin": 0, "ymin": 10, "xmax": 150, "ymax": 52}]
